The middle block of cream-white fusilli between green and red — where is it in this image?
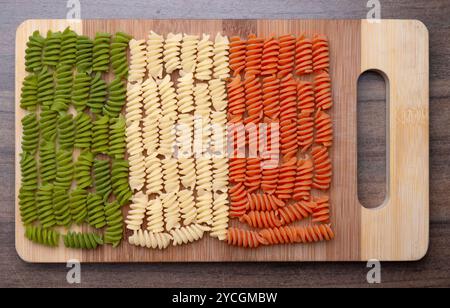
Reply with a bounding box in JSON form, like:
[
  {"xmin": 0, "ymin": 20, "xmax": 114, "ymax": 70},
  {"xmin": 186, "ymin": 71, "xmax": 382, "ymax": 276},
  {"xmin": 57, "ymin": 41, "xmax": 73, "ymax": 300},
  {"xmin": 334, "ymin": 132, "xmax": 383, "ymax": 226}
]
[{"xmin": 126, "ymin": 32, "xmax": 230, "ymax": 249}]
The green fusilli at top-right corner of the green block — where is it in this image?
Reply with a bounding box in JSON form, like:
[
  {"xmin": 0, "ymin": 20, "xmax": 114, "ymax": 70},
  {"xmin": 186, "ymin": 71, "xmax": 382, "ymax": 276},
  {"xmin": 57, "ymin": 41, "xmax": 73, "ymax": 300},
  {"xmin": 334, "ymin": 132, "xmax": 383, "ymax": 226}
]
[{"xmin": 111, "ymin": 32, "xmax": 131, "ymax": 78}]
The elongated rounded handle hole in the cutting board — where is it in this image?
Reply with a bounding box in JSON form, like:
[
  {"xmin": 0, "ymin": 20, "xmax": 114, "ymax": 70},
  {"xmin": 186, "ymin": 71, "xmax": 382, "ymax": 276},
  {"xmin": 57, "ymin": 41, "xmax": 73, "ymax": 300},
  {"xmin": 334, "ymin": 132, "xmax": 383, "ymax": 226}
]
[{"xmin": 357, "ymin": 70, "xmax": 389, "ymax": 209}]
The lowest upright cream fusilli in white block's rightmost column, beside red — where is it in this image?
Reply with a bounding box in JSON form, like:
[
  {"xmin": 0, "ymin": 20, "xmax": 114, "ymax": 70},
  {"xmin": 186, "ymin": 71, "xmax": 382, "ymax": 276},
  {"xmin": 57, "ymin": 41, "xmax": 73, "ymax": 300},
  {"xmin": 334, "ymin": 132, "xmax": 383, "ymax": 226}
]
[{"xmin": 210, "ymin": 193, "xmax": 230, "ymax": 241}]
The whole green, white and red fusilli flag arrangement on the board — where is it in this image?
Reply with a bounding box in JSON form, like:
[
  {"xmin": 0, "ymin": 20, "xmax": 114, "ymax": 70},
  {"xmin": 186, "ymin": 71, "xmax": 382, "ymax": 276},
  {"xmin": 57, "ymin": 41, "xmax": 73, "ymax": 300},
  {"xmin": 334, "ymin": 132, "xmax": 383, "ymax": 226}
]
[{"xmin": 18, "ymin": 29, "xmax": 334, "ymax": 250}]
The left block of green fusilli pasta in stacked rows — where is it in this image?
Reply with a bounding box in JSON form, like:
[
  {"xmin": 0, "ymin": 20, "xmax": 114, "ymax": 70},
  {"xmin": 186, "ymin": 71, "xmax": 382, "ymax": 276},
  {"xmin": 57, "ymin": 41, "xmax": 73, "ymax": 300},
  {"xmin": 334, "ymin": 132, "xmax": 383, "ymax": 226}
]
[{"xmin": 19, "ymin": 28, "xmax": 132, "ymax": 249}]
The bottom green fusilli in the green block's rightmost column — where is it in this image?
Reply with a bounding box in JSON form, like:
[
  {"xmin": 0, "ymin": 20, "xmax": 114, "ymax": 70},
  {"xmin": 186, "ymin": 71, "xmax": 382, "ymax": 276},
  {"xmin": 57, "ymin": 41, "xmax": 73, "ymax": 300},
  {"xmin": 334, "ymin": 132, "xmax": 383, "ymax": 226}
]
[{"xmin": 105, "ymin": 201, "xmax": 123, "ymax": 247}]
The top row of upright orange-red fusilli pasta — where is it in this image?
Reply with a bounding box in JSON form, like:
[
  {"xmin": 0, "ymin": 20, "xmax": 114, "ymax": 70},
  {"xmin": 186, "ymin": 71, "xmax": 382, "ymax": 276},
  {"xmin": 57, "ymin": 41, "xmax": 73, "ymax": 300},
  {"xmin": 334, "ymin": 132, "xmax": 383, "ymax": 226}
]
[{"xmin": 230, "ymin": 34, "xmax": 330, "ymax": 78}]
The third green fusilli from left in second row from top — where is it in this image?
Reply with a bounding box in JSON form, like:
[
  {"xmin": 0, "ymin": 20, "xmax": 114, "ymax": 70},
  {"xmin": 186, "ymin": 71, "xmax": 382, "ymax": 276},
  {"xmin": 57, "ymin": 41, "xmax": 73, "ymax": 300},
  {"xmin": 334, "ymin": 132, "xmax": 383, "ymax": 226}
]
[{"xmin": 52, "ymin": 65, "xmax": 73, "ymax": 112}]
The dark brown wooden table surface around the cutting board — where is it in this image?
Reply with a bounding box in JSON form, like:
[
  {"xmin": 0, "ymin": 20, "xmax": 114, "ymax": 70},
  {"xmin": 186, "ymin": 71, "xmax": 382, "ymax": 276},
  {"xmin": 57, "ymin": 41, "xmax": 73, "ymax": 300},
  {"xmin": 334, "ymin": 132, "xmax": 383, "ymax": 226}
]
[{"xmin": 0, "ymin": 0, "xmax": 450, "ymax": 288}]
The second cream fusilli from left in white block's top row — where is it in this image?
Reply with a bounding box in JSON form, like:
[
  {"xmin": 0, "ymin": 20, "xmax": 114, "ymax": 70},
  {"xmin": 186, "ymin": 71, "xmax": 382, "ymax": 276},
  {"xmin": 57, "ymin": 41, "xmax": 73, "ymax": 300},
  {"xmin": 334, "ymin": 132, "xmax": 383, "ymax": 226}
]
[{"xmin": 147, "ymin": 31, "xmax": 164, "ymax": 78}]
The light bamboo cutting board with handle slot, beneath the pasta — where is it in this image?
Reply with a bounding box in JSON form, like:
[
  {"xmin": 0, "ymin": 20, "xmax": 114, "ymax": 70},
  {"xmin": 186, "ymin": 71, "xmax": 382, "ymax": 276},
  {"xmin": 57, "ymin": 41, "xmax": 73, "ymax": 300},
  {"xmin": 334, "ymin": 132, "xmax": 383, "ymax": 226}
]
[{"xmin": 15, "ymin": 20, "xmax": 429, "ymax": 263}]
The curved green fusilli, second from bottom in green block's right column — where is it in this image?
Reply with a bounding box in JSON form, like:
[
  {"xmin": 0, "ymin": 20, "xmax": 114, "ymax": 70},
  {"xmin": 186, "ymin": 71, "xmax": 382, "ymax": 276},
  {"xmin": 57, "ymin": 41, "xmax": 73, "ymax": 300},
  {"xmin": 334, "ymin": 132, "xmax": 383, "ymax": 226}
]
[{"xmin": 111, "ymin": 159, "xmax": 133, "ymax": 206}]
